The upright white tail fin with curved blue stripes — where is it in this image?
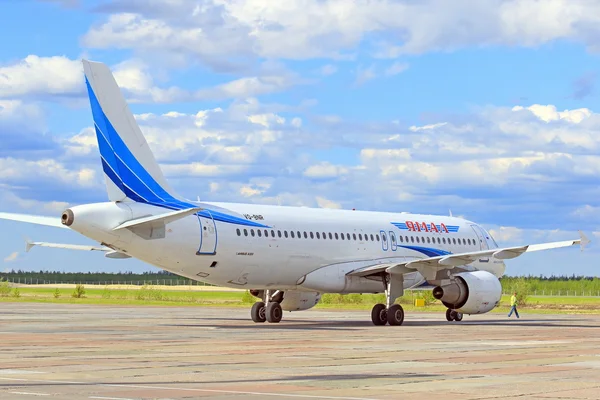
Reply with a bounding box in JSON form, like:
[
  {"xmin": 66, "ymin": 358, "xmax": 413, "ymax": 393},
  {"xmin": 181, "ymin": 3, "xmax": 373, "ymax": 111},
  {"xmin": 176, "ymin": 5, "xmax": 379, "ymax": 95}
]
[{"xmin": 83, "ymin": 60, "xmax": 180, "ymax": 208}]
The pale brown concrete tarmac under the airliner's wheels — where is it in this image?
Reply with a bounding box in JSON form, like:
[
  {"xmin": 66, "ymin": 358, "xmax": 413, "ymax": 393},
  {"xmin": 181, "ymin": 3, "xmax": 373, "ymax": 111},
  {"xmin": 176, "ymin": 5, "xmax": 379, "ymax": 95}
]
[{"xmin": 0, "ymin": 303, "xmax": 600, "ymax": 400}]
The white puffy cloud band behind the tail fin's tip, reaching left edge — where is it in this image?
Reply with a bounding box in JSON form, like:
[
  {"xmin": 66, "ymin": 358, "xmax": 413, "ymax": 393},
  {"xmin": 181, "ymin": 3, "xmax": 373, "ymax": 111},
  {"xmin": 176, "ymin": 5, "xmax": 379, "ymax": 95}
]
[{"xmin": 0, "ymin": 55, "xmax": 300, "ymax": 104}]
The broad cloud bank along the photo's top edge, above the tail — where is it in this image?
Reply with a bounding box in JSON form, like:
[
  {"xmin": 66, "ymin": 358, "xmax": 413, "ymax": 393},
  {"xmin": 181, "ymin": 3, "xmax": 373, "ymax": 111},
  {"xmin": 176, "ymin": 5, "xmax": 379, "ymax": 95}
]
[{"xmin": 83, "ymin": 0, "xmax": 600, "ymax": 65}]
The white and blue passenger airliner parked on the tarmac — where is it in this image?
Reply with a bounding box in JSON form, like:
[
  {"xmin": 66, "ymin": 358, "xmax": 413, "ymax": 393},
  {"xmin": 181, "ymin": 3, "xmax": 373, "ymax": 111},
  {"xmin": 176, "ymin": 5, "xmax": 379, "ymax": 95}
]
[{"xmin": 0, "ymin": 60, "xmax": 589, "ymax": 326}]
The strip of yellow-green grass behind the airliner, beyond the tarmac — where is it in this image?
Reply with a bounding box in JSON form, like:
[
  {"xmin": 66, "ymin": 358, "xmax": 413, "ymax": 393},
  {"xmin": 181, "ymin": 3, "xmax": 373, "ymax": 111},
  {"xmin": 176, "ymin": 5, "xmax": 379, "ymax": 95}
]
[{"xmin": 0, "ymin": 286, "xmax": 600, "ymax": 314}]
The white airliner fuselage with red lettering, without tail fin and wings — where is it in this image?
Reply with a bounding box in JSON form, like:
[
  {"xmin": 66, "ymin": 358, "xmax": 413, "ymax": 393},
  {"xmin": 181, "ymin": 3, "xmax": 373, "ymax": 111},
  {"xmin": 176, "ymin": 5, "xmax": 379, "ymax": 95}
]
[{"xmin": 71, "ymin": 202, "xmax": 505, "ymax": 293}]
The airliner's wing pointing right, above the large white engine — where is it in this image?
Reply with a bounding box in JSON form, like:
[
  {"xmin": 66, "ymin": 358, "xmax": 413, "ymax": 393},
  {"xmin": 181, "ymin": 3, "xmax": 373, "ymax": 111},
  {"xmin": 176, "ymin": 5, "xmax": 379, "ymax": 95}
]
[{"xmin": 347, "ymin": 231, "xmax": 590, "ymax": 279}]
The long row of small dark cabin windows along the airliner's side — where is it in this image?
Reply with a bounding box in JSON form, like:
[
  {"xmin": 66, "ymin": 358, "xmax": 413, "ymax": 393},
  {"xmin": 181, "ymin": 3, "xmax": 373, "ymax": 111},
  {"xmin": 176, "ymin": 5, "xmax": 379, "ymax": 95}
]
[{"xmin": 236, "ymin": 229, "xmax": 475, "ymax": 246}]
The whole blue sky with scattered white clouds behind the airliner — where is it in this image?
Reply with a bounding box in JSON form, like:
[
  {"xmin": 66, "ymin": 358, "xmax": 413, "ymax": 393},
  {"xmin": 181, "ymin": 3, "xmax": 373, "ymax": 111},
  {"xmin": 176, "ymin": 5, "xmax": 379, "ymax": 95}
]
[{"xmin": 0, "ymin": 0, "xmax": 600, "ymax": 275}]
